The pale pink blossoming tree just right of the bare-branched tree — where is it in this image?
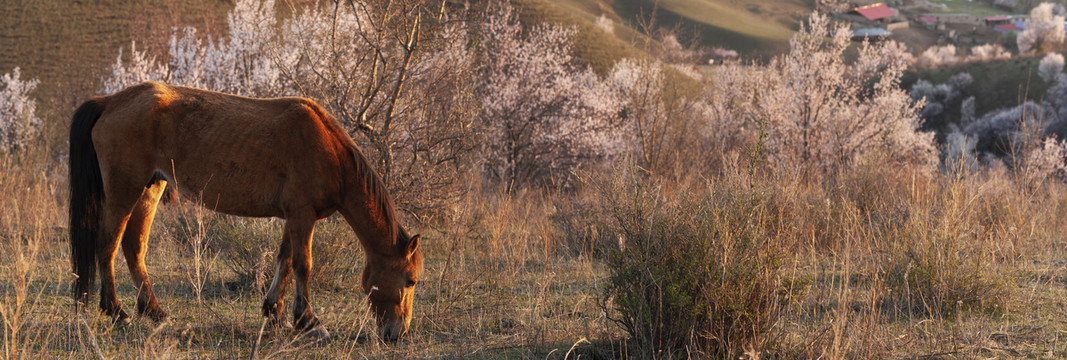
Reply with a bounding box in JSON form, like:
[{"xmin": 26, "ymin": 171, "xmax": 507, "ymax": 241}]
[{"xmin": 478, "ymin": 3, "xmax": 619, "ymax": 184}]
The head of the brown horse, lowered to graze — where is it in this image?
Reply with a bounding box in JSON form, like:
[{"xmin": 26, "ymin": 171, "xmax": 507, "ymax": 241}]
[{"xmin": 363, "ymin": 235, "xmax": 423, "ymax": 341}]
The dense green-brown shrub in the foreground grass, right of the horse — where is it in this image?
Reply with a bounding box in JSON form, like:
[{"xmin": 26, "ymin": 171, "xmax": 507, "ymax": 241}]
[{"xmin": 598, "ymin": 164, "xmax": 791, "ymax": 358}]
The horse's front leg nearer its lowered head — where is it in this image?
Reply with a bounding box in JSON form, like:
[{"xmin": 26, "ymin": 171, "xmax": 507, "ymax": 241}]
[{"xmin": 285, "ymin": 213, "xmax": 330, "ymax": 338}]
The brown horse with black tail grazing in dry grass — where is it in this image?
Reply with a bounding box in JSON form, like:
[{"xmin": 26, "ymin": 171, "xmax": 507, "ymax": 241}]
[{"xmin": 70, "ymin": 82, "xmax": 423, "ymax": 340}]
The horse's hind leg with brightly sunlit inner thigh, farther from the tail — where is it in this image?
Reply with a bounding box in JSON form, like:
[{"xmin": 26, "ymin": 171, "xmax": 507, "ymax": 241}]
[{"xmin": 123, "ymin": 179, "xmax": 166, "ymax": 322}]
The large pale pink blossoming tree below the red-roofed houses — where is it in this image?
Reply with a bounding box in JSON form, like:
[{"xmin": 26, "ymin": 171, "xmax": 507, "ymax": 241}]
[{"xmin": 711, "ymin": 13, "xmax": 937, "ymax": 172}]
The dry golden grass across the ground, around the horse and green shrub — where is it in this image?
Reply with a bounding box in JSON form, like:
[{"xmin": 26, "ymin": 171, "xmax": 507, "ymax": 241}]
[{"xmin": 6, "ymin": 146, "xmax": 1067, "ymax": 358}]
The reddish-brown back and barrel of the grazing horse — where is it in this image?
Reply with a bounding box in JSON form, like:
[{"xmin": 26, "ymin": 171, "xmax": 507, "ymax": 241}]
[{"xmin": 93, "ymin": 82, "xmax": 346, "ymax": 217}]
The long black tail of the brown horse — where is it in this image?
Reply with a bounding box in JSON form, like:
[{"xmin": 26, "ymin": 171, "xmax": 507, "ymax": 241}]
[{"xmin": 69, "ymin": 100, "xmax": 103, "ymax": 302}]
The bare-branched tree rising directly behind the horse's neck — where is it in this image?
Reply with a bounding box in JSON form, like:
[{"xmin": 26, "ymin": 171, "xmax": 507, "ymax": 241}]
[{"xmin": 275, "ymin": 1, "xmax": 478, "ymax": 213}]
